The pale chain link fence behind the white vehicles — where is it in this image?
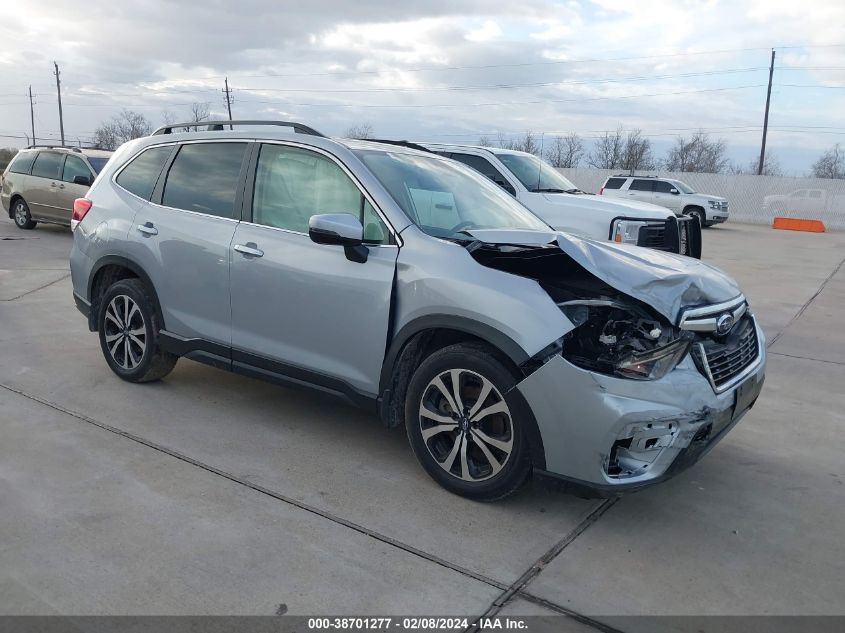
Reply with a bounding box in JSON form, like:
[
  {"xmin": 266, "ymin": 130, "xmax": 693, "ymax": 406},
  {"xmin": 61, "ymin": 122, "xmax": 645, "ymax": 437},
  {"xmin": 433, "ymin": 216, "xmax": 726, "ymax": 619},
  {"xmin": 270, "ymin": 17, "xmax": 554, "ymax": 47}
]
[{"xmin": 559, "ymin": 167, "xmax": 845, "ymax": 230}]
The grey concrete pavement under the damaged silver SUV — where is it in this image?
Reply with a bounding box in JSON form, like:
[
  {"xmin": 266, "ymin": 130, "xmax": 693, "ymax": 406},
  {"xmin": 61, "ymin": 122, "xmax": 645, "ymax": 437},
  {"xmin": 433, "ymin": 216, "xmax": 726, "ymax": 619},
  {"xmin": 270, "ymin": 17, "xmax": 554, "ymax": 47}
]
[{"xmin": 0, "ymin": 219, "xmax": 845, "ymax": 630}]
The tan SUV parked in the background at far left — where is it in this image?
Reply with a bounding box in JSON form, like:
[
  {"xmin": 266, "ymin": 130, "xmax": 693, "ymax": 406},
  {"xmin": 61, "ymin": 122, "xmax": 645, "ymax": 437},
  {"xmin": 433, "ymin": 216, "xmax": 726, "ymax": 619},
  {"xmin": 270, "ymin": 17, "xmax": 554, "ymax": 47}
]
[{"xmin": 0, "ymin": 145, "xmax": 112, "ymax": 229}]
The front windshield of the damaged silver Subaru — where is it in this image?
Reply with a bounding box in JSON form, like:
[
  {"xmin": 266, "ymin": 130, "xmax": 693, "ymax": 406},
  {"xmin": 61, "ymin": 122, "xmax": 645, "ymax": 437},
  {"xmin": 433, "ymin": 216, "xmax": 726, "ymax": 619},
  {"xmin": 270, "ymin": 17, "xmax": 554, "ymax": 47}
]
[{"xmin": 355, "ymin": 150, "xmax": 549, "ymax": 239}]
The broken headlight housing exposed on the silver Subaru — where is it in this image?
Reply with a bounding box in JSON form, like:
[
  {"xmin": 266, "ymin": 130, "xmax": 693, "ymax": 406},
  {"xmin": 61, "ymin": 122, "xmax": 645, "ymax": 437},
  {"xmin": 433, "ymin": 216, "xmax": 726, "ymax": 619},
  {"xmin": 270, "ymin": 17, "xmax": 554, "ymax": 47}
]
[{"xmin": 558, "ymin": 299, "xmax": 693, "ymax": 380}]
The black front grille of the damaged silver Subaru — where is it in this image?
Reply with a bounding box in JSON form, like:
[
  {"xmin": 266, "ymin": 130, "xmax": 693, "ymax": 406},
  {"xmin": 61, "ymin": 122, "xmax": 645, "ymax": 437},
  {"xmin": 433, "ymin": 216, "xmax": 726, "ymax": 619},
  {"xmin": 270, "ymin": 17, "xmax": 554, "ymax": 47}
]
[{"xmin": 696, "ymin": 315, "xmax": 760, "ymax": 391}]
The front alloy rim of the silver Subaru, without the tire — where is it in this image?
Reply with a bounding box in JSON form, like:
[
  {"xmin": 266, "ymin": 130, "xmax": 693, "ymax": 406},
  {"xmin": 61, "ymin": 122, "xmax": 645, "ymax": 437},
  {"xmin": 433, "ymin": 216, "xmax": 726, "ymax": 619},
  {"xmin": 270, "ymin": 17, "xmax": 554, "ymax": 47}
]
[{"xmin": 419, "ymin": 369, "xmax": 514, "ymax": 482}]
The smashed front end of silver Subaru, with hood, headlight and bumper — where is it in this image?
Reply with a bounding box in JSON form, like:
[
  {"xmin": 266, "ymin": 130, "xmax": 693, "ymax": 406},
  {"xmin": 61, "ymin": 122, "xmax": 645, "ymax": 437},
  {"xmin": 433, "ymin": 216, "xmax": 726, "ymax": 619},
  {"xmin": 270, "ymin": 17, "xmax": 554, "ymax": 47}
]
[{"xmin": 462, "ymin": 228, "xmax": 765, "ymax": 494}]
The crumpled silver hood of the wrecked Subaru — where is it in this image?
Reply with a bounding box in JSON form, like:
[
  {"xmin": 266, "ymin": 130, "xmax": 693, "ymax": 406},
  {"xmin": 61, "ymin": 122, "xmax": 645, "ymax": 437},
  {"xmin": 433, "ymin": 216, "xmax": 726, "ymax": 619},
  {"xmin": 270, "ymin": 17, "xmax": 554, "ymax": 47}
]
[{"xmin": 469, "ymin": 229, "xmax": 742, "ymax": 323}]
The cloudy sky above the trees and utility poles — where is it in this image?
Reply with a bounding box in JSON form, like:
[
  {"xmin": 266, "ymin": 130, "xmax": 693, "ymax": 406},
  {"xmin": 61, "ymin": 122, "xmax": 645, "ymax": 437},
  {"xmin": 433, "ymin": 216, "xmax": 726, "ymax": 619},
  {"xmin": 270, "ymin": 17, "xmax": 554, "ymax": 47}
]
[{"xmin": 0, "ymin": 0, "xmax": 845, "ymax": 174}]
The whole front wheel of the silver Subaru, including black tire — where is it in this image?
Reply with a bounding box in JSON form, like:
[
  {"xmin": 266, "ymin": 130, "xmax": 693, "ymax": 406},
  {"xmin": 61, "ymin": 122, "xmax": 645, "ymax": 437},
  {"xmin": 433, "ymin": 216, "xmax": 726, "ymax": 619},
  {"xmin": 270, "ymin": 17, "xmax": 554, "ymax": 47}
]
[{"xmin": 405, "ymin": 343, "xmax": 531, "ymax": 501}]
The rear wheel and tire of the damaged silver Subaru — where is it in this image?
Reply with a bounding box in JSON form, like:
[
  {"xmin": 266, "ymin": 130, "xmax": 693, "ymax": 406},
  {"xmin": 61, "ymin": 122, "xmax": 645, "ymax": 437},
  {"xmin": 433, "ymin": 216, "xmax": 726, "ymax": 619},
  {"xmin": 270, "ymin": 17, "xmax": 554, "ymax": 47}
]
[{"xmin": 97, "ymin": 279, "xmax": 178, "ymax": 382}]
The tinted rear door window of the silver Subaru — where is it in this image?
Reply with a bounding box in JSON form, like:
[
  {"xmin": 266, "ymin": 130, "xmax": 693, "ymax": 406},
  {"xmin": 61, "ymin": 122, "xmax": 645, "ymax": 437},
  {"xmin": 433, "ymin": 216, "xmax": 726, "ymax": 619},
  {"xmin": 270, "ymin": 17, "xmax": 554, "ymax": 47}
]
[{"xmin": 161, "ymin": 143, "xmax": 247, "ymax": 218}]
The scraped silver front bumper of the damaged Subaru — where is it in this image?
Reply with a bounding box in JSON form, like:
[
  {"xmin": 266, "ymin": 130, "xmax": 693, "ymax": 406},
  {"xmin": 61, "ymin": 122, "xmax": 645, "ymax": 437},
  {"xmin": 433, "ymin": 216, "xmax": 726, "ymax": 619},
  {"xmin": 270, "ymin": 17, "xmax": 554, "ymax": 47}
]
[{"xmin": 517, "ymin": 325, "xmax": 766, "ymax": 496}]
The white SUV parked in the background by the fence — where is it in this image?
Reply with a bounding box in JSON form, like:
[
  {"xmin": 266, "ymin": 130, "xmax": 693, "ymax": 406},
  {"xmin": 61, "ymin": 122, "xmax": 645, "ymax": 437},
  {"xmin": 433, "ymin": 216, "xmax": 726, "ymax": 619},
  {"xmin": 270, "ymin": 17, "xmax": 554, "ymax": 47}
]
[{"xmin": 599, "ymin": 174, "xmax": 729, "ymax": 227}]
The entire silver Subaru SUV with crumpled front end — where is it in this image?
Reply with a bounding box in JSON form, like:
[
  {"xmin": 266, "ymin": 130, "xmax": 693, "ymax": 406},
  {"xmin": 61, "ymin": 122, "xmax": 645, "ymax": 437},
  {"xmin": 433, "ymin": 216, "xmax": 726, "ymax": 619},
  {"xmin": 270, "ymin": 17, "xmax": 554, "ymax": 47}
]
[{"xmin": 70, "ymin": 122, "xmax": 765, "ymax": 499}]
